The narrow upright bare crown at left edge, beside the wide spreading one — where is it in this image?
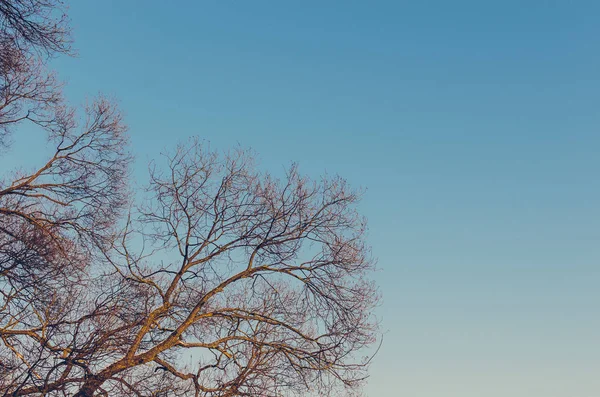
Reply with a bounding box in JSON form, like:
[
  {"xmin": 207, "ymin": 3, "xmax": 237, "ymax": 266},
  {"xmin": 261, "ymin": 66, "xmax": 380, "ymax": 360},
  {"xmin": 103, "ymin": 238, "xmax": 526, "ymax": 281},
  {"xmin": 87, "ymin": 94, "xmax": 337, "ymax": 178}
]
[{"xmin": 0, "ymin": 99, "xmax": 129, "ymax": 390}]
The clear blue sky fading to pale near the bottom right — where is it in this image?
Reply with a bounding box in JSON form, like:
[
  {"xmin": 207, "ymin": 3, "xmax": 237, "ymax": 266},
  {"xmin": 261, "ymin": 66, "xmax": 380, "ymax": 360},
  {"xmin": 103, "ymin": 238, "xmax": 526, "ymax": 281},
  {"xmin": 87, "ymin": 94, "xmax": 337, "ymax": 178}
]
[{"xmin": 9, "ymin": 0, "xmax": 600, "ymax": 397}]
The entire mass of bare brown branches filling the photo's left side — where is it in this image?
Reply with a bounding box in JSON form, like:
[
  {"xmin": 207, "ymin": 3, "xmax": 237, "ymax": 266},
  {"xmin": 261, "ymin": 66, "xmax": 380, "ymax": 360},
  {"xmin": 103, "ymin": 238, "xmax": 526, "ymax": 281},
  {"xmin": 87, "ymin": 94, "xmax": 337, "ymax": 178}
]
[{"xmin": 0, "ymin": 0, "xmax": 377, "ymax": 397}]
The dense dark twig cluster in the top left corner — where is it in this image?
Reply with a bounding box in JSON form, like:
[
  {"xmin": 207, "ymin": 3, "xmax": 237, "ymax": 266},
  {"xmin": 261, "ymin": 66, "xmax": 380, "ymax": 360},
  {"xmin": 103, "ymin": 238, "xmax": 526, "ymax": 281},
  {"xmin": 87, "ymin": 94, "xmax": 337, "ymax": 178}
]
[{"xmin": 0, "ymin": 0, "xmax": 71, "ymax": 145}]
